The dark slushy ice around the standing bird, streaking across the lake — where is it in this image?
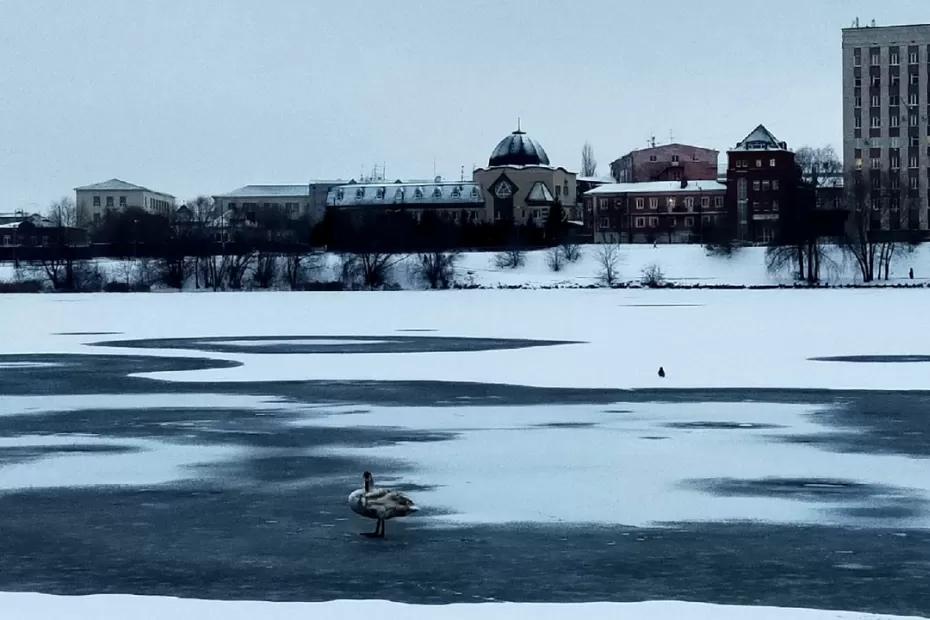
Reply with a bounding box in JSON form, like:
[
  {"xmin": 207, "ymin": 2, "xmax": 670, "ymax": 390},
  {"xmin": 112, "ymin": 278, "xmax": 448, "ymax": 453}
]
[{"xmin": 0, "ymin": 346, "xmax": 930, "ymax": 615}]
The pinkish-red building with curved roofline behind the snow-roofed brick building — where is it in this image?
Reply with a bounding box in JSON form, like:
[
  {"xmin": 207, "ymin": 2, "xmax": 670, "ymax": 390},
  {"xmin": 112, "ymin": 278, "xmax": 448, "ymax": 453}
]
[{"xmin": 610, "ymin": 144, "xmax": 719, "ymax": 183}]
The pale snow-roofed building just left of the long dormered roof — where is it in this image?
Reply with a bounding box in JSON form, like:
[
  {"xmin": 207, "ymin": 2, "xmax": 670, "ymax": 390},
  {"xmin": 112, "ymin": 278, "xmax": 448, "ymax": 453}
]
[{"xmin": 213, "ymin": 179, "xmax": 345, "ymax": 224}]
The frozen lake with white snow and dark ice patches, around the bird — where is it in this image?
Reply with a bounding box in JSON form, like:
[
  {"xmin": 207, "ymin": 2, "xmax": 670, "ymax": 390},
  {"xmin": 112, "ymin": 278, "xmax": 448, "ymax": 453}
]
[{"xmin": 0, "ymin": 290, "xmax": 930, "ymax": 615}]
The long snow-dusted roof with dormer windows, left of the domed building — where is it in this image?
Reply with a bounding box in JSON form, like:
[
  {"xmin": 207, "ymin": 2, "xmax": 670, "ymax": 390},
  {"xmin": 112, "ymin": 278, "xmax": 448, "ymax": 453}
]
[{"xmin": 326, "ymin": 181, "xmax": 484, "ymax": 207}]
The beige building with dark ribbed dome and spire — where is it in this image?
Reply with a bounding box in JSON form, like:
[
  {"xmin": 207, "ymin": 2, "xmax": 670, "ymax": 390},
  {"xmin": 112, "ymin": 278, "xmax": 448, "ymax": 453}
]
[{"xmin": 473, "ymin": 127, "xmax": 576, "ymax": 225}]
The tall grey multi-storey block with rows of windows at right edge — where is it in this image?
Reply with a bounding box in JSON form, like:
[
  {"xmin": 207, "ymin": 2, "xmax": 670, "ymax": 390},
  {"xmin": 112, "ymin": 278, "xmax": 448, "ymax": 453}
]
[{"xmin": 843, "ymin": 24, "xmax": 930, "ymax": 231}]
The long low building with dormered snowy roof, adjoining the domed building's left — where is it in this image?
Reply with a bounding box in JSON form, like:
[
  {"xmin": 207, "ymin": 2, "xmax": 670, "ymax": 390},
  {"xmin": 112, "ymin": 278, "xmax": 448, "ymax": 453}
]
[{"xmin": 326, "ymin": 177, "xmax": 486, "ymax": 224}]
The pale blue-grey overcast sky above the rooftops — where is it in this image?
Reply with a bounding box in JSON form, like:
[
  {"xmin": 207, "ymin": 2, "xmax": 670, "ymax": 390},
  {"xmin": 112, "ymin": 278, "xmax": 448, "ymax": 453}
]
[{"xmin": 0, "ymin": 0, "xmax": 930, "ymax": 211}]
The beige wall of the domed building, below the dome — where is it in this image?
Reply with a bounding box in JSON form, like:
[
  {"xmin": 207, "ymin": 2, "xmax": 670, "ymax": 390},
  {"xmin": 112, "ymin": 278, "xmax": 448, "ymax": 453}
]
[{"xmin": 473, "ymin": 166, "xmax": 577, "ymax": 225}]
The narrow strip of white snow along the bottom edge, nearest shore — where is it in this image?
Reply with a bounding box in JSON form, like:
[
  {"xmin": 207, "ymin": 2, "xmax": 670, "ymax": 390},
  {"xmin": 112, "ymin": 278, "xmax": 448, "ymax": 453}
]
[{"xmin": 0, "ymin": 593, "xmax": 919, "ymax": 620}]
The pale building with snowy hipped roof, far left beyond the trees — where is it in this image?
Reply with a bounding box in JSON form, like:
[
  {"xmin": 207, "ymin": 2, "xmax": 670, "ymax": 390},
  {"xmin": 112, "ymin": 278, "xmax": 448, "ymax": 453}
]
[{"xmin": 74, "ymin": 179, "xmax": 175, "ymax": 227}]
